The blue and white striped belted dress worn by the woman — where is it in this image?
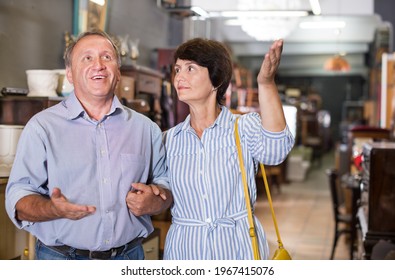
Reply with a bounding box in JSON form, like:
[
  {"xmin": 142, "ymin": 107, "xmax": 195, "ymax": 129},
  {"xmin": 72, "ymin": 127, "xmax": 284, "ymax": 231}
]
[{"xmin": 164, "ymin": 107, "xmax": 294, "ymax": 260}]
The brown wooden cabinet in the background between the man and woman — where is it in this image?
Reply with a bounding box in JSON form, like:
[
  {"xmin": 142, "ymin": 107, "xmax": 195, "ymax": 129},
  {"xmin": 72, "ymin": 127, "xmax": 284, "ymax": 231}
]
[{"xmin": 121, "ymin": 65, "xmax": 163, "ymax": 126}]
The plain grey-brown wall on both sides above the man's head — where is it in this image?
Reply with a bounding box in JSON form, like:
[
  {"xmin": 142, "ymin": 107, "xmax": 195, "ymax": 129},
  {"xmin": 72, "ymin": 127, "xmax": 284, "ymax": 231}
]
[{"xmin": 0, "ymin": 0, "xmax": 182, "ymax": 88}]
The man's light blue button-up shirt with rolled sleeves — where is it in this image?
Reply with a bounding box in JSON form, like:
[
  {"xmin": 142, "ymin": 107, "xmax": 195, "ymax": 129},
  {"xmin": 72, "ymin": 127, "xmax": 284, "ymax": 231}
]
[{"xmin": 6, "ymin": 94, "xmax": 169, "ymax": 251}]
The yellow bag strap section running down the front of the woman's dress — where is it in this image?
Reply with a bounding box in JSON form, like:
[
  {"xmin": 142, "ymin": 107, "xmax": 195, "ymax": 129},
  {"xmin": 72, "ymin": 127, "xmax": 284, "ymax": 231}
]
[{"xmin": 235, "ymin": 118, "xmax": 261, "ymax": 260}]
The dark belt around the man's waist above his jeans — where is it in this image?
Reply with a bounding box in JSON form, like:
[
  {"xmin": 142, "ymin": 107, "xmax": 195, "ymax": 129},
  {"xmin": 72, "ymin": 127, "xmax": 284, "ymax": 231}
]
[{"xmin": 41, "ymin": 237, "xmax": 143, "ymax": 260}]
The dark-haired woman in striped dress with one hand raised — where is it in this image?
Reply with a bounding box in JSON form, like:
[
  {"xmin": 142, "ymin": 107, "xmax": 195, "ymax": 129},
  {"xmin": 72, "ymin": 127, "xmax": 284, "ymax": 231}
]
[{"xmin": 164, "ymin": 38, "xmax": 294, "ymax": 260}]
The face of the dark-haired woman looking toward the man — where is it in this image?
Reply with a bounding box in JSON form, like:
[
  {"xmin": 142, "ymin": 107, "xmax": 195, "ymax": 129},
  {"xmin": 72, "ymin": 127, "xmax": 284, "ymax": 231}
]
[{"xmin": 173, "ymin": 59, "xmax": 216, "ymax": 105}]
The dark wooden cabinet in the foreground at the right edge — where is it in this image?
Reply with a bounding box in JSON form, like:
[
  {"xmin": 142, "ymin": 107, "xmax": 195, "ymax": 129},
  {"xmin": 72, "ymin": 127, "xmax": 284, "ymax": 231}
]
[{"xmin": 358, "ymin": 142, "xmax": 395, "ymax": 259}]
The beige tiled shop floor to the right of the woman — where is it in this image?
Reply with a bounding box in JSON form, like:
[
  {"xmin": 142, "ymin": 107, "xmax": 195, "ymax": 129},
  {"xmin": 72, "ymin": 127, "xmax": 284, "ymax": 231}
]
[{"xmin": 255, "ymin": 153, "xmax": 349, "ymax": 260}]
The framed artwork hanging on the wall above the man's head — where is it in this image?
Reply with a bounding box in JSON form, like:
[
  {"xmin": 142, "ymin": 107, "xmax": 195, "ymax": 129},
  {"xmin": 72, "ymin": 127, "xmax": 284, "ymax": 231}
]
[{"xmin": 73, "ymin": 0, "xmax": 109, "ymax": 36}]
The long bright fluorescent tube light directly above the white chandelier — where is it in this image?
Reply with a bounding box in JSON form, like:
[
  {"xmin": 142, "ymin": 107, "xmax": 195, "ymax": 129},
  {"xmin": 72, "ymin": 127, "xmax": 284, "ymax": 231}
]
[{"xmin": 210, "ymin": 10, "xmax": 309, "ymax": 18}]
